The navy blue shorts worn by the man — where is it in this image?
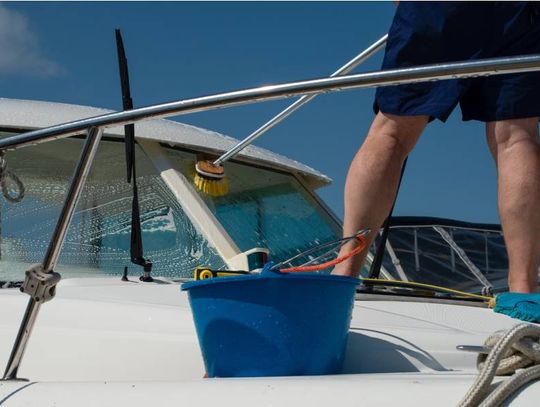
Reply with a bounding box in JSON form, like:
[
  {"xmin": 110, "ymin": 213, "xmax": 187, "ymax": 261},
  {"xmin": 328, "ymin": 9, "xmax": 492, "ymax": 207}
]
[{"xmin": 374, "ymin": 2, "xmax": 540, "ymax": 122}]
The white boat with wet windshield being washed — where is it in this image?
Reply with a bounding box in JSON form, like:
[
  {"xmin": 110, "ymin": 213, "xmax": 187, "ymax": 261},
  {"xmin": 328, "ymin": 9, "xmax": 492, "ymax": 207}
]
[{"xmin": 0, "ymin": 51, "xmax": 540, "ymax": 406}]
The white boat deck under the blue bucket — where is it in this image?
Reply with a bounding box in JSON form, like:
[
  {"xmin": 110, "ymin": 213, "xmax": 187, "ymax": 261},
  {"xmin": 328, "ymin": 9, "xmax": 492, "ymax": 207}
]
[{"xmin": 0, "ymin": 277, "xmax": 540, "ymax": 406}]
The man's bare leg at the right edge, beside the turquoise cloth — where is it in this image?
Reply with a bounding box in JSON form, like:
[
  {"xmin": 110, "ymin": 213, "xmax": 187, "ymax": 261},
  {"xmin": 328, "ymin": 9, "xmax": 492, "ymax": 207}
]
[{"xmin": 486, "ymin": 117, "xmax": 540, "ymax": 293}]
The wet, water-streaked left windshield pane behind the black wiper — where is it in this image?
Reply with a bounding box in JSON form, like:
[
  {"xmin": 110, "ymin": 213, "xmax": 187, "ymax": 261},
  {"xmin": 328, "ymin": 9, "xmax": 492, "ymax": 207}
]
[{"xmin": 0, "ymin": 133, "xmax": 223, "ymax": 281}]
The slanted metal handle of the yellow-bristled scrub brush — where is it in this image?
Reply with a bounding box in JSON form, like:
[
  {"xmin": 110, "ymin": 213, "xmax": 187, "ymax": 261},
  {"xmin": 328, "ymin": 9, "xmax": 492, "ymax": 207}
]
[{"xmin": 213, "ymin": 34, "xmax": 388, "ymax": 165}]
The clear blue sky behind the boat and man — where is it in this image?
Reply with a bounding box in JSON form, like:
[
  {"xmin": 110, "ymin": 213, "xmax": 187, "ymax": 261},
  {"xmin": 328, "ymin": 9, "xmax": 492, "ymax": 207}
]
[{"xmin": 0, "ymin": 2, "xmax": 499, "ymax": 223}]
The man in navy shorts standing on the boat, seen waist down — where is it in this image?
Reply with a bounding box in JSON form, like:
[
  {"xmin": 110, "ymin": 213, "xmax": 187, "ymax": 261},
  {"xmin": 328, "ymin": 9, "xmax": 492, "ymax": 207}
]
[{"xmin": 333, "ymin": 2, "xmax": 540, "ymax": 293}]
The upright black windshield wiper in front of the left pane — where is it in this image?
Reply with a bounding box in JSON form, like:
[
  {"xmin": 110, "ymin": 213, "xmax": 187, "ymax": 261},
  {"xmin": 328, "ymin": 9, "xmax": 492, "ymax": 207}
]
[{"xmin": 115, "ymin": 29, "xmax": 153, "ymax": 281}]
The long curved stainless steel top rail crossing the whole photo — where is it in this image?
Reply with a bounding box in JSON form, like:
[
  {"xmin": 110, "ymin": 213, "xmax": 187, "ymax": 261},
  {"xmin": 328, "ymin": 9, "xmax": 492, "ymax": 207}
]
[{"xmin": 0, "ymin": 55, "xmax": 540, "ymax": 150}]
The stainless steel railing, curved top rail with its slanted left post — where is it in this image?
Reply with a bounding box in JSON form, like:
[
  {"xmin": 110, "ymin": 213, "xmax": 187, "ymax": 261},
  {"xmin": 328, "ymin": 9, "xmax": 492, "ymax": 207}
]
[{"xmin": 0, "ymin": 51, "xmax": 540, "ymax": 380}]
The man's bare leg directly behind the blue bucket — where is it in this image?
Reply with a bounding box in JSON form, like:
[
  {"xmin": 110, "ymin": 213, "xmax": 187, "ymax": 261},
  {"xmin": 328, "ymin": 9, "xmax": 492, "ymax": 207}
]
[{"xmin": 332, "ymin": 112, "xmax": 429, "ymax": 277}]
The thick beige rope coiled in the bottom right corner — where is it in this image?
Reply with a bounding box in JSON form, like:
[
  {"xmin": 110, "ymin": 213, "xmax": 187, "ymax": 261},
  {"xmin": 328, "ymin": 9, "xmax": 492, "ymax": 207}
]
[{"xmin": 458, "ymin": 323, "xmax": 540, "ymax": 407}]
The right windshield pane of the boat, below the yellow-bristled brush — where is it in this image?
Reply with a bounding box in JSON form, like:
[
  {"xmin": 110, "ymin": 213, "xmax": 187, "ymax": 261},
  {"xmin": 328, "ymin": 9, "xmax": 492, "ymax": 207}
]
[{"xmin": 167, "ymin": 149, "xmax": 341, "ymax": 270}]
